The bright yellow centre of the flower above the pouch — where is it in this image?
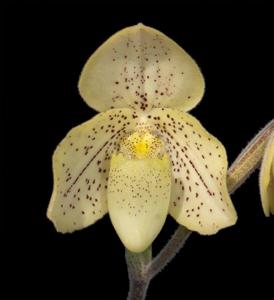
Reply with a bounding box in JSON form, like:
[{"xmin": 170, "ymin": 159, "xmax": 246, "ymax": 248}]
[{"xmin": 120, "ymin": 131, "xmax": 163, "ymax": 159}]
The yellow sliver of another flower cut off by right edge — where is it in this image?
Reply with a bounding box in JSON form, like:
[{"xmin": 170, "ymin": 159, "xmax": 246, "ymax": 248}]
[{"xmin": 259, "ymin": 132, "xmax": 274, "ymax": 217}]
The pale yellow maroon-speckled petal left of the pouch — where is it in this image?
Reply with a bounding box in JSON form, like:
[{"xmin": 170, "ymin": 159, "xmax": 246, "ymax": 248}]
[{"xmin": 47, "ymin": 109, "xmax": 135, "ymax": 233}]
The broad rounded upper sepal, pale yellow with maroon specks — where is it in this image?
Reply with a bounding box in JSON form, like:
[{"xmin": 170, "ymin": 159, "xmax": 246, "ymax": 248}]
[{"xmin": 79, "ymin": 24, "xmax": 204, "ymax": 111}]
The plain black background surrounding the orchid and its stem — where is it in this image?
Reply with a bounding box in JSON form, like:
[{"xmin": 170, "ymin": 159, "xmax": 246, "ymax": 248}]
[{"xmin": 1, "ymin": 0, "xmax": 274, "ymax": 300}]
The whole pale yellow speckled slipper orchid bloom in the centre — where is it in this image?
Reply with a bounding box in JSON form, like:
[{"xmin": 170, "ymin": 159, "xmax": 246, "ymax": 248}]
[{"xmin": 48, "ymin": 24, "xmax": 237, "ymax": 252}]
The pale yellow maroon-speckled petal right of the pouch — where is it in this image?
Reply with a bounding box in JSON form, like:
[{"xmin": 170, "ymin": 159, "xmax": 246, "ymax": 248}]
[{"xmin": 148, "ymin": 109, "xmax": 237, "ymax": 234}]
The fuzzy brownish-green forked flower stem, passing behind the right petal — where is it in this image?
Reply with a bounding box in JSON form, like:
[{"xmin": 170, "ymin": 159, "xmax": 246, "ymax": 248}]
[{"xmin": 126, "ymin": 120, "xmax": 274, "ymax": 300}]
